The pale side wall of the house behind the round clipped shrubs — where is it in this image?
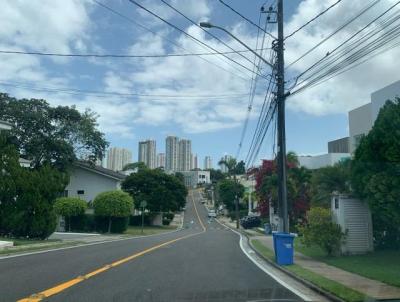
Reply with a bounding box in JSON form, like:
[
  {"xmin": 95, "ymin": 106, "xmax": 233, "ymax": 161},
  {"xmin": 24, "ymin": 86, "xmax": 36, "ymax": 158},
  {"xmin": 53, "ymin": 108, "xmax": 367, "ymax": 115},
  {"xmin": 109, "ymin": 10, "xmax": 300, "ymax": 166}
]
[{"xmin": 65, "ymin": 167, "xmax": 121, "ymax": 202}]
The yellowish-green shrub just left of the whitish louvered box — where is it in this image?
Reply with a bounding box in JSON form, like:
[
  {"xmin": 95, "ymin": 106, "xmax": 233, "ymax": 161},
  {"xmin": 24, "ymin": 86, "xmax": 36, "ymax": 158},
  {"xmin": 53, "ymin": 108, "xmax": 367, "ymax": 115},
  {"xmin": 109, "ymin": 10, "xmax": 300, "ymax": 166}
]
[{"xmin": 298, "ymin": 207, "xmax": 345, "ymax": 256}]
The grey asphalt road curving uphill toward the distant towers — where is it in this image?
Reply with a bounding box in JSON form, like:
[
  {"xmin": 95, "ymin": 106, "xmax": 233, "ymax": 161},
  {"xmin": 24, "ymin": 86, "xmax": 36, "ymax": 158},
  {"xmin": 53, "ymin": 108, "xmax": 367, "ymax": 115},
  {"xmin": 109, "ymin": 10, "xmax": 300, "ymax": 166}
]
[{"xmin": 0, "ymin": 192, "xmax": 301, "ymax": 302}]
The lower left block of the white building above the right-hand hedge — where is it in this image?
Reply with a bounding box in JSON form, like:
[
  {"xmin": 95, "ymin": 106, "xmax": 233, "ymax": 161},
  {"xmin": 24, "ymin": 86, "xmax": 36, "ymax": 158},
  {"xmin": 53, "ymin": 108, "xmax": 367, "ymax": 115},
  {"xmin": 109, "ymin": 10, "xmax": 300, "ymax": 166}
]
[{"xmin": 349, "ymin": 103, "xmax": 373, "ymax": 153}]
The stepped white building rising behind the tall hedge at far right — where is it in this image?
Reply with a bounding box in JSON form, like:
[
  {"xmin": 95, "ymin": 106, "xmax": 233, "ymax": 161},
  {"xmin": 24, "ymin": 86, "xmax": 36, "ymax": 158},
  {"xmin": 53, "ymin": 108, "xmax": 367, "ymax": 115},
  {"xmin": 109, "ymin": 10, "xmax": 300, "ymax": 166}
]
[{"xmin": 349, "ymin": 81, "xmax": 400, "ymax": 153}]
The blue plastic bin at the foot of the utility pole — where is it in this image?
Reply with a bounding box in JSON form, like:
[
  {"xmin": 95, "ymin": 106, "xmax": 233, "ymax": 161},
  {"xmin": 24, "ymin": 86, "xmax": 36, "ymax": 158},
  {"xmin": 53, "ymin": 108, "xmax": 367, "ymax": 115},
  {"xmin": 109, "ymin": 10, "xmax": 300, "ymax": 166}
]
[{"xmin": 272, "ymin": 232, "xmax": 295, "ymax": 265}]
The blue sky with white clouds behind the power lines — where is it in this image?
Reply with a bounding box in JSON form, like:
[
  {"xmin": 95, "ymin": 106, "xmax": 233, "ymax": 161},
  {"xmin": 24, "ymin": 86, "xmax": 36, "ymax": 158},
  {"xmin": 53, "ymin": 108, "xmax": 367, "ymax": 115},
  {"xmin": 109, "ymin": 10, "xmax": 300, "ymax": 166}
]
[{"xmin": 0, "ymin": 0, "xmax": 398, "ymax": 165}]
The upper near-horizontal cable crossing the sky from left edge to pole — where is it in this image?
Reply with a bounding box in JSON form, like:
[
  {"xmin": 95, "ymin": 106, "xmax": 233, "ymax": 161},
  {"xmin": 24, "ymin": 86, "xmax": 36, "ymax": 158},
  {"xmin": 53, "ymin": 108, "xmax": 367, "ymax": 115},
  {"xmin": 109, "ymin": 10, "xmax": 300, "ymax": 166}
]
[{"xmin": 0, "ymin": 48, "xmax": 271, "ymax": 59}]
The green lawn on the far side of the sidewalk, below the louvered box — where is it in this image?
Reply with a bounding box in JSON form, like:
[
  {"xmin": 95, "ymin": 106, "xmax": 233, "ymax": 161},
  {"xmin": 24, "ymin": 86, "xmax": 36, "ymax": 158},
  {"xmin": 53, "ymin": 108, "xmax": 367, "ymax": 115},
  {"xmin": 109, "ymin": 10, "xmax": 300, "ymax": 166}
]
[{"xmin": 295, "ymin": 240, "xmax": 400, "ymax": 287}]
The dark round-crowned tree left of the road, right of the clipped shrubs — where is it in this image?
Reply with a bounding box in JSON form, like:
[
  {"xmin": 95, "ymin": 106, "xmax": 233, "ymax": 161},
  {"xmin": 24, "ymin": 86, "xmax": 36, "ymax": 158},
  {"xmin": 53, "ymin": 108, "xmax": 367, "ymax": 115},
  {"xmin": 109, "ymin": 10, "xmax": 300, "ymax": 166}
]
[{"xmin": 122, "ymin": 169, "xmax": 187, "ymax": 212}]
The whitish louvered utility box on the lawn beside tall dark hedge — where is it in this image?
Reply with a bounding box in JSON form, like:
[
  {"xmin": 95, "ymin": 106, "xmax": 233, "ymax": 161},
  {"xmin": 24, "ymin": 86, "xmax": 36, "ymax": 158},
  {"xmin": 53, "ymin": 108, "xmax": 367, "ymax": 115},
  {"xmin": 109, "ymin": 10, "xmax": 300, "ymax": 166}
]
[{"xmin": 331, "ymin": 194, "xmax": 374, "ymax": 254}]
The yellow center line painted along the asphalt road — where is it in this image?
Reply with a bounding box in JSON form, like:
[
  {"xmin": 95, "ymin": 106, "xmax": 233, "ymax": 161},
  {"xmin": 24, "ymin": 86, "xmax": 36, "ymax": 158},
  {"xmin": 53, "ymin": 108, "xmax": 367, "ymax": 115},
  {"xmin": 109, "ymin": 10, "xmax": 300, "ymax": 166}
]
[{"xmin": 18, "ymin": 195, "xmax": 206, "ymax": 302}]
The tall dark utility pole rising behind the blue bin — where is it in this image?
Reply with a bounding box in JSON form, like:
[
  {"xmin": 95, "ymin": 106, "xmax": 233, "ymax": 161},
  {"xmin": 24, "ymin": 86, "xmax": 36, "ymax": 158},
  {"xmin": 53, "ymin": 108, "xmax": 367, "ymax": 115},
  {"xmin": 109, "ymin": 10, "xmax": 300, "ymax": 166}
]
[{"xmin": 275, "ymin": 0, "xmax": 289, "ymax": 233}]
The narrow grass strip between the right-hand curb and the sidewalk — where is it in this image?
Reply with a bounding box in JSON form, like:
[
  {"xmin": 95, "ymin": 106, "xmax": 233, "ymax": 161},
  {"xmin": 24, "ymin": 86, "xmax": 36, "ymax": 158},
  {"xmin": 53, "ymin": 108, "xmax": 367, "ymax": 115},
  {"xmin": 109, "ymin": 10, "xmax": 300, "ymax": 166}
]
[{"xmin": 251, "ymin": 240, "xmax": 366, "ymax": 302}]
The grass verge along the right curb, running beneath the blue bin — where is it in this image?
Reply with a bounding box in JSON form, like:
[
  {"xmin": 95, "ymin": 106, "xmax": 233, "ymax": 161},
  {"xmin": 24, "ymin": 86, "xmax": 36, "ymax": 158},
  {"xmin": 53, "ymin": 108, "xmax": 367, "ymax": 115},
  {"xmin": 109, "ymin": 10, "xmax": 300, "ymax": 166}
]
[{"xmin": 249, "ymin": 239, "xmax": 368, "ymax": 302}]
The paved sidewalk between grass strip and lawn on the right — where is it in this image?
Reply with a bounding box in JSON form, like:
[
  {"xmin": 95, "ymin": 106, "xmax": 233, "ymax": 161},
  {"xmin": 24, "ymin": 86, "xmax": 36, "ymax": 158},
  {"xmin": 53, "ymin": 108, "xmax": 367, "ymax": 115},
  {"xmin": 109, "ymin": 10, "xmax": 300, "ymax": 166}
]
[{"xmin": 252, "ymin": 235, "xmax": 400, "ymax": 300}]
